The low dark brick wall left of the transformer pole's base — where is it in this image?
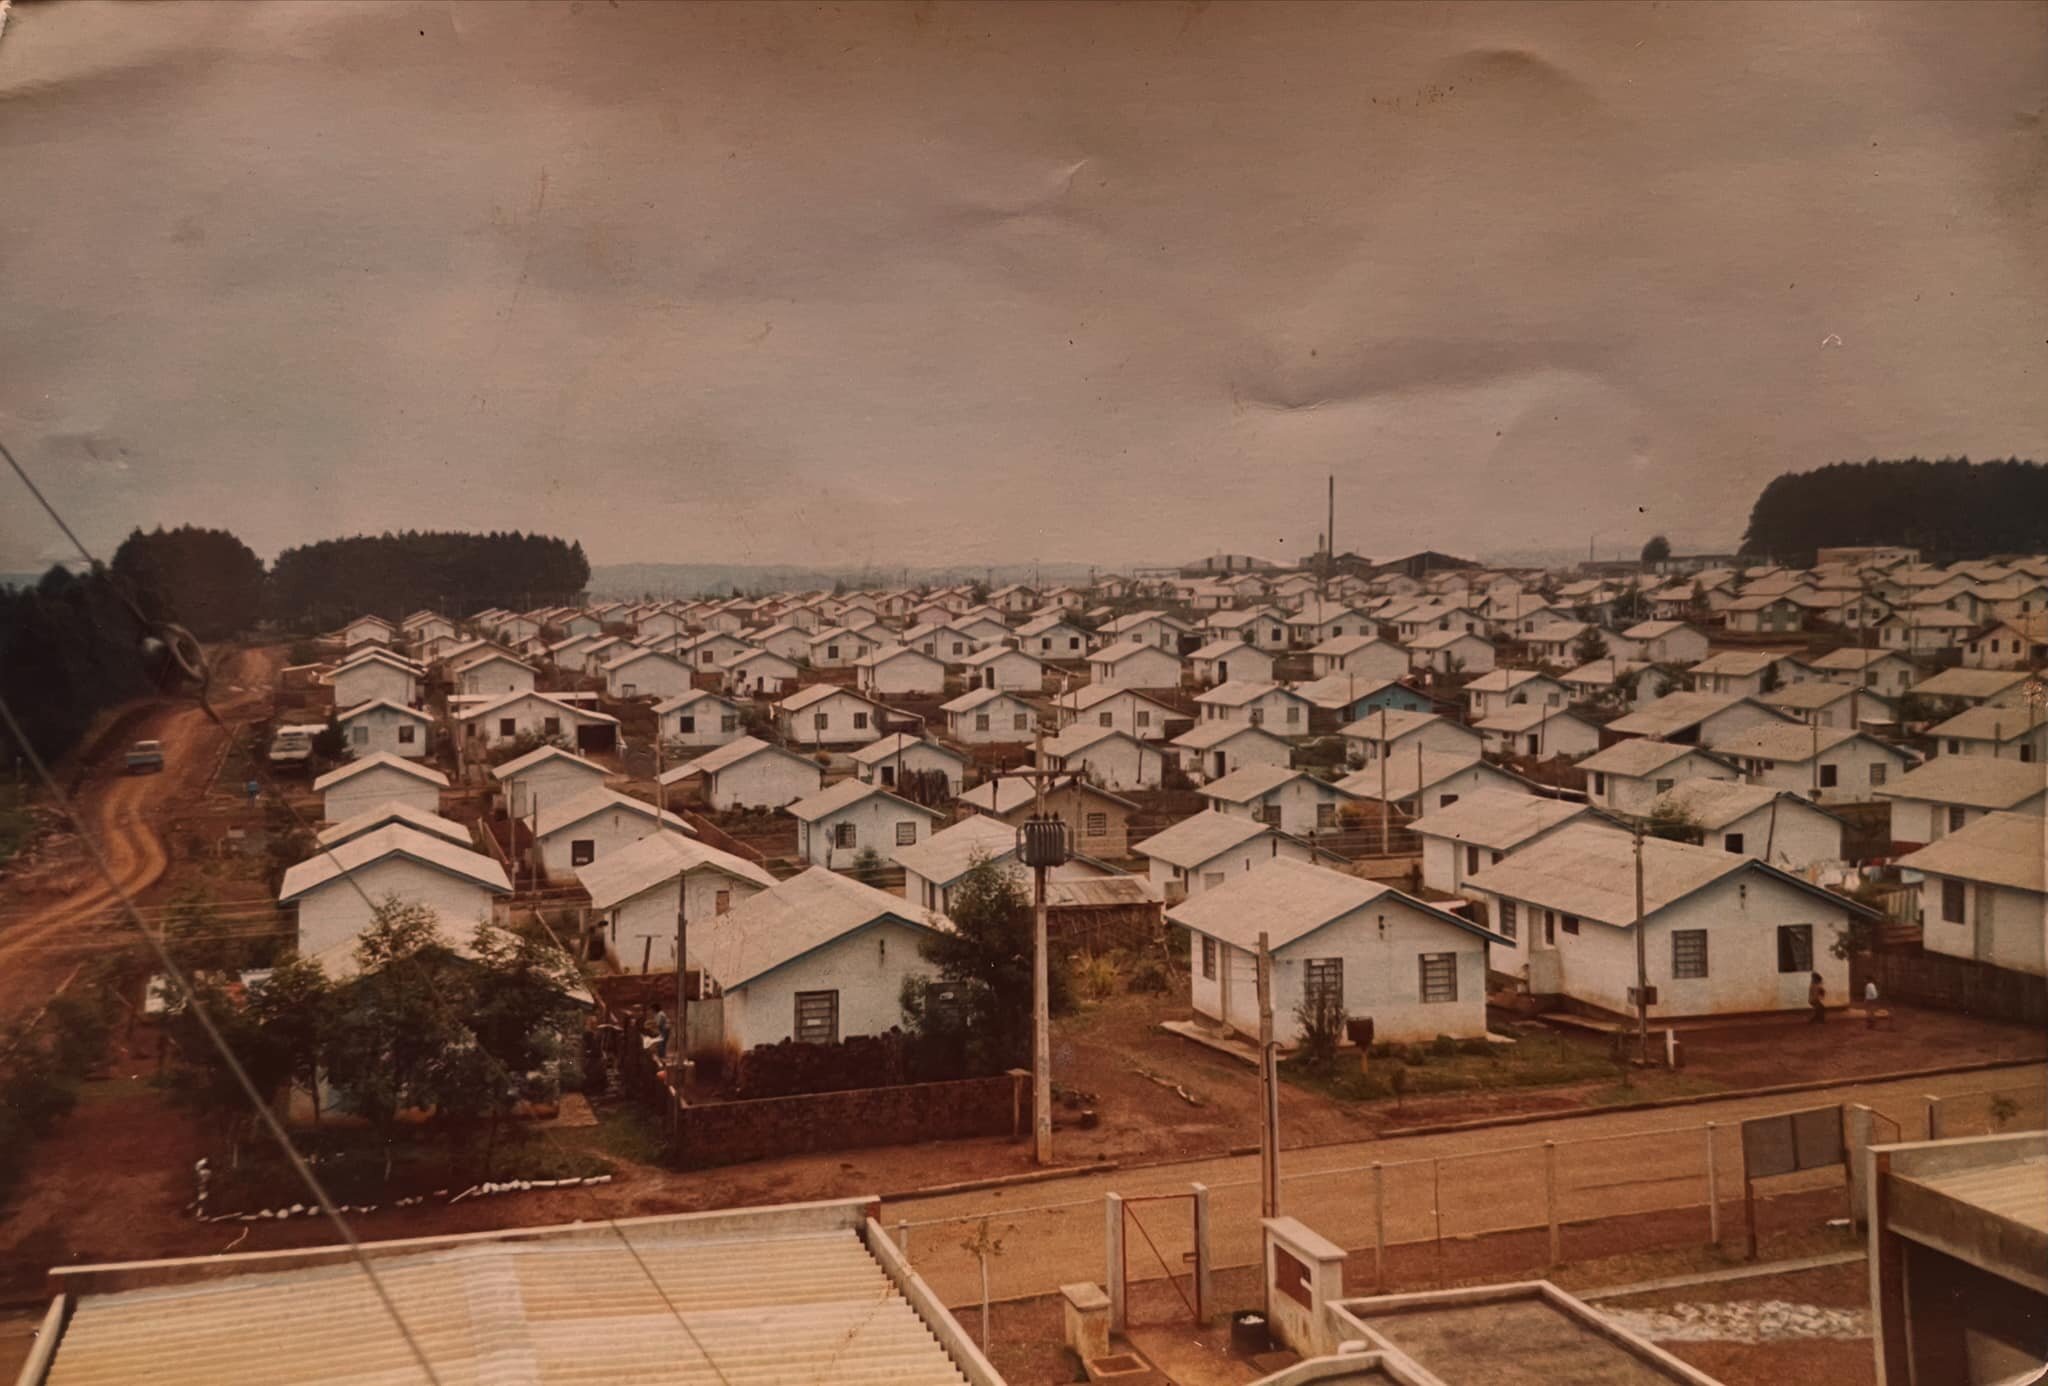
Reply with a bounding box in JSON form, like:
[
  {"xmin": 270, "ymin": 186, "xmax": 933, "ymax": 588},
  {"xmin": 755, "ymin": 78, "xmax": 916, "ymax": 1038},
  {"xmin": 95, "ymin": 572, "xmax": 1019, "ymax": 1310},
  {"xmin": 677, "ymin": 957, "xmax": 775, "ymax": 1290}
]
[{"xmin": 678, "ymin": 1073, "xmax": 1030, "ymax": 1167}]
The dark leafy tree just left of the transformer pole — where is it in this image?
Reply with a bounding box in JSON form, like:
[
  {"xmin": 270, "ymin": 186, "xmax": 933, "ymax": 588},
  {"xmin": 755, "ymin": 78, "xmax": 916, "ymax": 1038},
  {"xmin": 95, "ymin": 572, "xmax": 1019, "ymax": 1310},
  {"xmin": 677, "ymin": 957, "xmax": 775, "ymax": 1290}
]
[{"xmin": 903, "ymin": 858, "xmax": 1071, "ymax": 1073}]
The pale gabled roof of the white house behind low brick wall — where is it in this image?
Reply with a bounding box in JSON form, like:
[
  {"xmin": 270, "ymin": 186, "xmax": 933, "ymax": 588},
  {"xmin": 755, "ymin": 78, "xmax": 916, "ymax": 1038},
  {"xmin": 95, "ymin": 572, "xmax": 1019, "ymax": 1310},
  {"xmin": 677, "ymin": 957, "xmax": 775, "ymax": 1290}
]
[{"xmin": 690, "ymin": 866, "xmax": 952, "ymax": 991}]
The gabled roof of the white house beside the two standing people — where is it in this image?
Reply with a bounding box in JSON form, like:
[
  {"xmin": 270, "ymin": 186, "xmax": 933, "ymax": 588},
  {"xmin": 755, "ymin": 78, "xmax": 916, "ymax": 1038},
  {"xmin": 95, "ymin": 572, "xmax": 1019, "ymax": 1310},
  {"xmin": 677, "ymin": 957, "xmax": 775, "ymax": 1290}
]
[{"xmin": 1466, "ymin": 823, "xmax": 1874, "ymax": 942}]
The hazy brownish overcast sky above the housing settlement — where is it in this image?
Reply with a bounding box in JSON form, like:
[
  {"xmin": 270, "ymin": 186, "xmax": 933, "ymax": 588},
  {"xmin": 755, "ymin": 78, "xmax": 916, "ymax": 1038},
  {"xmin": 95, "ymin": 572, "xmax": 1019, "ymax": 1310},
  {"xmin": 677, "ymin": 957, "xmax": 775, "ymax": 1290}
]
[{"xmin": 0, "ymin": 0, "xmax": 2048, "ymax": 571}]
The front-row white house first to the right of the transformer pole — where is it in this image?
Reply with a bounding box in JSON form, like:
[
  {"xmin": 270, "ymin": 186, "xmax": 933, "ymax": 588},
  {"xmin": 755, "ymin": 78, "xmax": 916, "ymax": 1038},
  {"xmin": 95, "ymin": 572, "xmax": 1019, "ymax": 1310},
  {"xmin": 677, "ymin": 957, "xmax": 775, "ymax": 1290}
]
[{"xmin": 1167, "ymin": 860, "xmax": 1503, "ymax": 1044}]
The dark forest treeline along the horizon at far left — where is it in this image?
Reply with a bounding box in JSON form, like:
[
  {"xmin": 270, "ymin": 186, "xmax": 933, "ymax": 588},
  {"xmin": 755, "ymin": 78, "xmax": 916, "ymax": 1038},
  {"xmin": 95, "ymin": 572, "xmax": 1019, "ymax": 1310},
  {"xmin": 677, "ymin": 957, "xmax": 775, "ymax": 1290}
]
[{"xmin": 0, "ymin": 526, "xmax": 590, "ymax": 760}]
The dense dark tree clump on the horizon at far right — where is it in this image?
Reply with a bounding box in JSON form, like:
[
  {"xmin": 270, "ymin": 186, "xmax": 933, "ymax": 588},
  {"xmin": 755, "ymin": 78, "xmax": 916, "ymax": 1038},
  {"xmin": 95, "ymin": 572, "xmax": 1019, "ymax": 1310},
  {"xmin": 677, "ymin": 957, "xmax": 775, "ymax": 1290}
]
[{"xmin": 1743, "ymin": 457, "xmax": 2048, "ymax": 563}]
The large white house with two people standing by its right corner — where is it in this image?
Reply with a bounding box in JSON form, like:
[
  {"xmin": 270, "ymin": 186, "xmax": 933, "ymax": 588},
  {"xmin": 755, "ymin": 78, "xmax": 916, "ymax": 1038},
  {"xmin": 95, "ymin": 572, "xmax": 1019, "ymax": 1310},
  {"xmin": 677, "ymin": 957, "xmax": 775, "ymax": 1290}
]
[{"xmin": 1466, "ymin": 823, "xmax": 1874, "ymax": 1020}]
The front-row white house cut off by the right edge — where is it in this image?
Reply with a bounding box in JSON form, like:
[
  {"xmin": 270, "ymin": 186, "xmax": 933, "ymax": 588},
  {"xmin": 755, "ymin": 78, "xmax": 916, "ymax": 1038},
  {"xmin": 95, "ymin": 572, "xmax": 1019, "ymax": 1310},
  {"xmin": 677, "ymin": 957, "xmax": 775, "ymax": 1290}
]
[{"xmin": 1898, "ymin": 813, "xmax": 2048, "ymax": 977}]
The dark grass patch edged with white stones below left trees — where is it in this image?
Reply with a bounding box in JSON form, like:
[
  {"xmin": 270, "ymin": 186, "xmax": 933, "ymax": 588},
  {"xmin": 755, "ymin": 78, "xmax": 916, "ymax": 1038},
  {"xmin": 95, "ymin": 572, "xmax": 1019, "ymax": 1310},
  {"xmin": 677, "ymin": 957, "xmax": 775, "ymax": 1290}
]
[{"xmin": 207, "ymin": 1128, "xmax": 612, "ymax": 1214}]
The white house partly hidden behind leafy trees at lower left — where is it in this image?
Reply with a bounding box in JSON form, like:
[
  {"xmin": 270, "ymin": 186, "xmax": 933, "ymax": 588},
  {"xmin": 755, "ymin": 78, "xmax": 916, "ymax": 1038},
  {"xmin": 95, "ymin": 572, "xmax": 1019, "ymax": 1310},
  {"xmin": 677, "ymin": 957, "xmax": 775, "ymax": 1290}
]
[{"xmin": 276, "ymin": 823, "xmax": 512, "ymax": 979}]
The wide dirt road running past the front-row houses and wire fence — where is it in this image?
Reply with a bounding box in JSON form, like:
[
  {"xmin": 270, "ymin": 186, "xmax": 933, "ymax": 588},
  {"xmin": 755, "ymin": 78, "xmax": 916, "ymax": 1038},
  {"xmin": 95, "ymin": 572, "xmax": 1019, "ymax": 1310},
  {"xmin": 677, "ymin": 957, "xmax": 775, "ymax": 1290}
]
[{"xmin": 883, "ymin": 1065, "xmax": 2048, "ymax": 1306}]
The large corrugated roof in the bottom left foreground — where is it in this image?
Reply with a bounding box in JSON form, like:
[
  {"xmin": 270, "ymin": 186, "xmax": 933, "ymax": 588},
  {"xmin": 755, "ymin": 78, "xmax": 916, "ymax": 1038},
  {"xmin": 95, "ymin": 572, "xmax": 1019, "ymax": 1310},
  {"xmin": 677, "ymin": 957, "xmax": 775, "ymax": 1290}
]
[{"xmin": 47, "ymin": 1226, "xmax": 967, "ymax": 1386}]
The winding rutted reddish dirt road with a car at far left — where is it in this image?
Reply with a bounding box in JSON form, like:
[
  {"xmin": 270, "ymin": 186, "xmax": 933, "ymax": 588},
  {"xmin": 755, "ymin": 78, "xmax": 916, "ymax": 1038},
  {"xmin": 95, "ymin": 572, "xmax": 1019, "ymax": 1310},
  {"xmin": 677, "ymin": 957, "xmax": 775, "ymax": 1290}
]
[{"xmin": 0, "ymin": 649, "xmax": 283, "ymax": 1017}]
